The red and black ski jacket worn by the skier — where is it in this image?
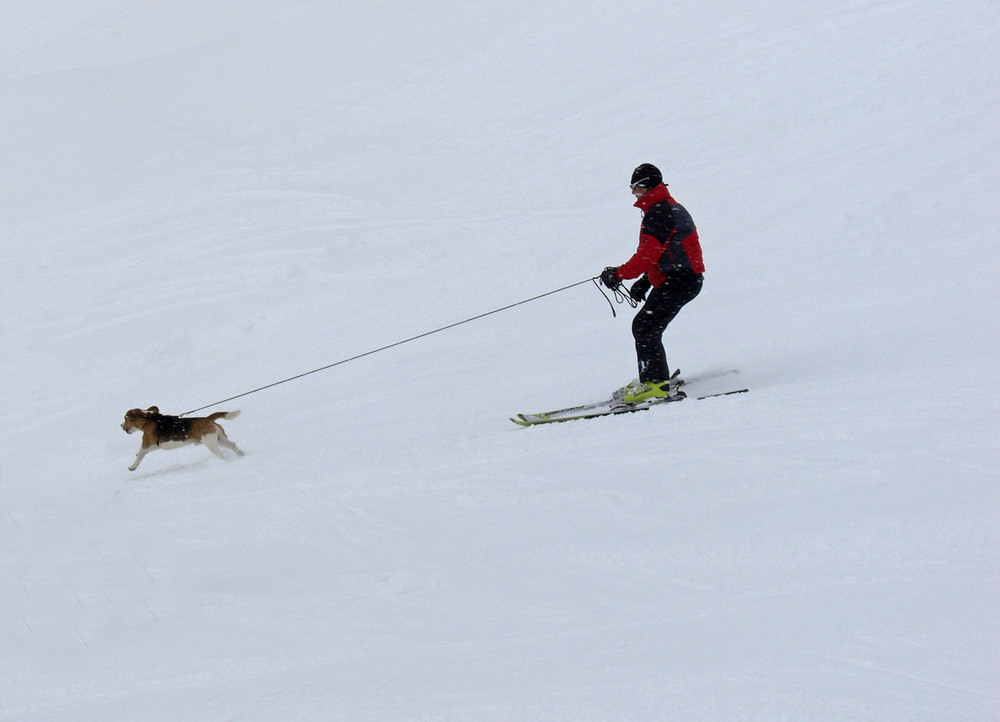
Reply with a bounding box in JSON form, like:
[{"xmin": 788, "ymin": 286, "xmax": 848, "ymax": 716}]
[{"xmin": 615, "ymin": 183, "xmax": 705, "ymax": 286}]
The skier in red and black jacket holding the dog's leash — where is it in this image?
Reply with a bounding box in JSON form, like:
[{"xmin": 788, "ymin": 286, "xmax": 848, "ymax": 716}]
[{"xmin": 601, "ymin": 163, "xmax": 705, "ymax": 404}]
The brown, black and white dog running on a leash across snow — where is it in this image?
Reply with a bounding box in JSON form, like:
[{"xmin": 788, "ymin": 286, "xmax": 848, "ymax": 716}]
[{"xmin": 122, "ymin": 406, "xmax": 243, "ymax": 471}]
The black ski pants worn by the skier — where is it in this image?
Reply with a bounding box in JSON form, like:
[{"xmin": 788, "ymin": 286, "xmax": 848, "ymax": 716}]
[{"xmin": 632, "ymin": 273, "xmax": 703, "ymax": 381}]
